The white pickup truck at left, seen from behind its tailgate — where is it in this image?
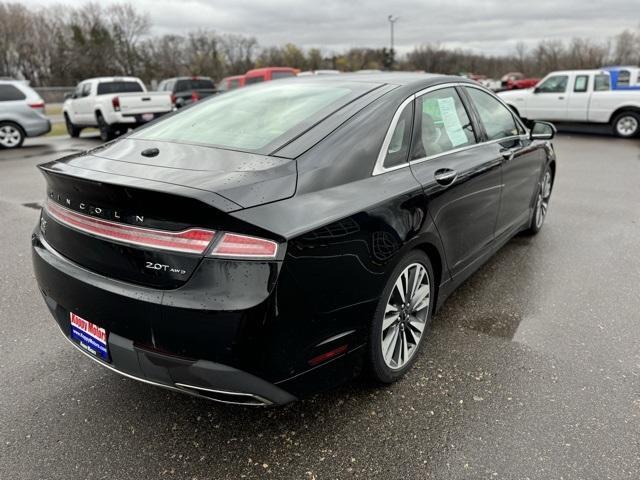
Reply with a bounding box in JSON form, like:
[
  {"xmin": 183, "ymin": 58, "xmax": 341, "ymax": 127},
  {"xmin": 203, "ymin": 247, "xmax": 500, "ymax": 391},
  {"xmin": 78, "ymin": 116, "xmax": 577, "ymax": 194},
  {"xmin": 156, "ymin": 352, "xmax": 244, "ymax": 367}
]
[{"xmin": 62, "ymin": 77, "xmax": 173, "ymax": 141}]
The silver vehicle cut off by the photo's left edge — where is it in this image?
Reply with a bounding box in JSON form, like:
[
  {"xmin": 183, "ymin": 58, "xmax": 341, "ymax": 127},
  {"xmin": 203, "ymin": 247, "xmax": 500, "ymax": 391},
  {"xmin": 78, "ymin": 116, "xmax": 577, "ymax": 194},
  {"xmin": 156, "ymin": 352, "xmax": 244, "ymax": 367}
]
[{"xmin": 0, "ymin": 80, "xmax": 51, "ymax": 148}]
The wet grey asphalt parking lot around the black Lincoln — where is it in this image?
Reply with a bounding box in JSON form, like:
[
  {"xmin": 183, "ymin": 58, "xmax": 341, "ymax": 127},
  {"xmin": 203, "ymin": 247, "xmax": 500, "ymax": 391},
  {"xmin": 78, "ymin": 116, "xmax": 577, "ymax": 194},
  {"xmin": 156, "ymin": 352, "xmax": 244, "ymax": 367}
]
[{"xmin": 0, "ymin": 133, "xmax": 640, "ymax": 480}]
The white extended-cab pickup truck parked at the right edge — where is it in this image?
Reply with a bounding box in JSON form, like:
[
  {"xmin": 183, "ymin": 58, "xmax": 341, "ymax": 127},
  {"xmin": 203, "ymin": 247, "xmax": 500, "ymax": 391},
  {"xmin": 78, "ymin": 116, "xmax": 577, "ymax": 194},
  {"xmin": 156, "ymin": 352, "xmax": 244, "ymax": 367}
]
[{"xmin": 498, "ymin": 70, "xmax": 640, "ymax": 138}]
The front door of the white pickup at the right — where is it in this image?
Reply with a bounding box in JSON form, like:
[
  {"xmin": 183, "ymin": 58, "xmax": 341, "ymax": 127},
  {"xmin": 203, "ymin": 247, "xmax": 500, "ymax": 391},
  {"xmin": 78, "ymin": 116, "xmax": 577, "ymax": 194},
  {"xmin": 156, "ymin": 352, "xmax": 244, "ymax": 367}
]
[{"xmin": 527, "ymin": 74, "xmax": 569, "ymax": 120}]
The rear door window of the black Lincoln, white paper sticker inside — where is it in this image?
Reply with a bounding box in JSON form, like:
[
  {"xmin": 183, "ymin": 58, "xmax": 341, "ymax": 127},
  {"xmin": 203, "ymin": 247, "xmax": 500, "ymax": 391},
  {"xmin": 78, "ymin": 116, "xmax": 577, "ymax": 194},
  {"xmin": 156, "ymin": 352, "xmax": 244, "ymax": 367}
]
[{"xmin": 411, "ymin": 88, "xmax": 476, "ymax": 160}]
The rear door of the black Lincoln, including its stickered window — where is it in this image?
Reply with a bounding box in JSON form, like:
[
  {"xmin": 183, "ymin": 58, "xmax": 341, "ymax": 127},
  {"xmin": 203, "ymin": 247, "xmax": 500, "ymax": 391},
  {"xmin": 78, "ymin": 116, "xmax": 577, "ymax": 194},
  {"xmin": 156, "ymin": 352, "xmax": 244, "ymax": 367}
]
[{"xmin": 410, "ymin": 86, "xmax": 501, "ymax": 276}]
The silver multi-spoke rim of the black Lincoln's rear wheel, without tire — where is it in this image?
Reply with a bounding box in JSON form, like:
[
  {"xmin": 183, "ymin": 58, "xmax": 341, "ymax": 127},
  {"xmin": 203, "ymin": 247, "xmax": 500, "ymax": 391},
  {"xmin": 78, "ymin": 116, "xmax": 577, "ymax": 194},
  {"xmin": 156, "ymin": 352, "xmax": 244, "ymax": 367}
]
[{"xmin": 381, "ymin": 263, "xmax": 431, "ymax": 370}]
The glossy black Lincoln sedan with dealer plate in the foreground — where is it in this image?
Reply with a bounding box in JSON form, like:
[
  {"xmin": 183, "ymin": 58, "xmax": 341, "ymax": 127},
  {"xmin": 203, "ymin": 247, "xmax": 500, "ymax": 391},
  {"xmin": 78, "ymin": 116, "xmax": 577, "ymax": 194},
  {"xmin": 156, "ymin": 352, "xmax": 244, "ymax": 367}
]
[{"xmin": 32, "ymin": 73, "xmax": 556, "ymax": 405}]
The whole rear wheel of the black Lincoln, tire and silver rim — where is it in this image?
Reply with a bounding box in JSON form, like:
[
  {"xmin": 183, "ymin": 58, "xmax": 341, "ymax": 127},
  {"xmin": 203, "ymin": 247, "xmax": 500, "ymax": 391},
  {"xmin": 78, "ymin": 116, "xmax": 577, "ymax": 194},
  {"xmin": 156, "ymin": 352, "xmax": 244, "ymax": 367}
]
[{"xmin": 369, "ymin": 250, "xmax": 435, "ymax": 383}]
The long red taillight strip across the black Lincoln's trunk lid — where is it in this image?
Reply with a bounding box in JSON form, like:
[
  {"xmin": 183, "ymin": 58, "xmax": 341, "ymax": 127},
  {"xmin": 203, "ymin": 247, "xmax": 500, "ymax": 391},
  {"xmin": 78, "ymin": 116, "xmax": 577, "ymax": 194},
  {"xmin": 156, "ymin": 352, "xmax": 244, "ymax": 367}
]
[{"xmin": 46, "ymin": 200, "xmax": 215, "ymax": 254}]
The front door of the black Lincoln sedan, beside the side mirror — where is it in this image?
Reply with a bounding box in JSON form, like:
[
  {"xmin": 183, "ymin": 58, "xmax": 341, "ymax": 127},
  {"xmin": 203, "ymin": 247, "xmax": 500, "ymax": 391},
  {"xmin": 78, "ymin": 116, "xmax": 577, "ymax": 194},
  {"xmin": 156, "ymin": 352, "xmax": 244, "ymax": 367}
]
[{"xmin": 464, "ymin": 86, "xmax": 544, "ymax": 238}]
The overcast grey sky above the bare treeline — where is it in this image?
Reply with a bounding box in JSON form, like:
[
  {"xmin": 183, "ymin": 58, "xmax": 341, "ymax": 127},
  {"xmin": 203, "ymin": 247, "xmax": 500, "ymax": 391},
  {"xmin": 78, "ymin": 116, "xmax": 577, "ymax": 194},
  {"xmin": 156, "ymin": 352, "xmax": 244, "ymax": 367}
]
[{"xmin": 20, "ymin": 0, "xmax": 640, "ymax": 54}]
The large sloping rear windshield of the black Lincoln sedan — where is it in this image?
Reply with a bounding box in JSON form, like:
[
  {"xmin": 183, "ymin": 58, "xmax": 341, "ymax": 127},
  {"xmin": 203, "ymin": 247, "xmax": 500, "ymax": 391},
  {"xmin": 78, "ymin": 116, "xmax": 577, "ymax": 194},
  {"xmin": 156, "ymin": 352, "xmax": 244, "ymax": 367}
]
[{"xmin": 130, "ymin": 82, "xmax": 372, "ymax": 153}]
